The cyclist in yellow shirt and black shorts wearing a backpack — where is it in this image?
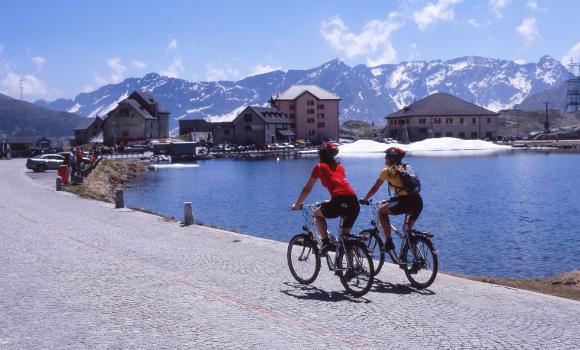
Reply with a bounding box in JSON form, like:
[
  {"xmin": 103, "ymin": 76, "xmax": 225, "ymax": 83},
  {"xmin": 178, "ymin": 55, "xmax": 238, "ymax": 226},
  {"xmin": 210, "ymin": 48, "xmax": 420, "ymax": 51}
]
[{"xmin": 360, "ymin": 147, "xmax": 423, "ymax": 251}]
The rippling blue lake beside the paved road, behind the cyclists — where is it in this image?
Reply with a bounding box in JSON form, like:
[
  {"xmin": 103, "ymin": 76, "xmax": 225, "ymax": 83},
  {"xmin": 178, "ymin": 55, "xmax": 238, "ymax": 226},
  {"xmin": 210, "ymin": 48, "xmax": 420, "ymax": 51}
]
[{"xmin": 125, "ymin": 151, "xmax": 580, "ymax": 277}]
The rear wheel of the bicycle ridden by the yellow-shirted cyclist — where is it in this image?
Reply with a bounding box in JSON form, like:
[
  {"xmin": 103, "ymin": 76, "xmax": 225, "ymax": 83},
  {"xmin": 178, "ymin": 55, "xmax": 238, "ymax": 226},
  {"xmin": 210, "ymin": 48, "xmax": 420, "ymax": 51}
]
[{"xmin": 402, "ymin": 236, "xmax": 439, "ymax": 289}]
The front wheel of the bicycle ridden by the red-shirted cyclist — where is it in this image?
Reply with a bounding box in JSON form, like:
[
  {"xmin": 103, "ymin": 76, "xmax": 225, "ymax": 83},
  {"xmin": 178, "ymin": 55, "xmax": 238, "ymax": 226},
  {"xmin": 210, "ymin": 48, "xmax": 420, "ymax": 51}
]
[{"xmin": 286, "ymin": 234, "xmax": 320, "ymax": 284}]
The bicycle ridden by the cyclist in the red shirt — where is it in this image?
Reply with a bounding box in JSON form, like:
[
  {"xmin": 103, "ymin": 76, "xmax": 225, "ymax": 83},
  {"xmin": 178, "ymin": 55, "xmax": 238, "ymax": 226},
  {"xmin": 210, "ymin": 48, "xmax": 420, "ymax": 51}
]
[{"xmin": 287, "ymin": 203, "xmax": 374, "ymax": 298}]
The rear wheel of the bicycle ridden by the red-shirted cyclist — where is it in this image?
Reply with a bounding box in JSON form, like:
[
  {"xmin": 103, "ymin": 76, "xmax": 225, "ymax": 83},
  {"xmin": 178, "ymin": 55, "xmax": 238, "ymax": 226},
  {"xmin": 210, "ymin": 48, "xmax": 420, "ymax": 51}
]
[{"xmin": 337, "ymin": 241, "xmax": 374, "ymax": 298}]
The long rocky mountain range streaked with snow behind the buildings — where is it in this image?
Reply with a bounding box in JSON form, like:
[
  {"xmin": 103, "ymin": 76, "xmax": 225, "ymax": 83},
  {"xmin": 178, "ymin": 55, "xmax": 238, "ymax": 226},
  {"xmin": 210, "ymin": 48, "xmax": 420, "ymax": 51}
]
[{"xmin": 37, "ymin": 56, "xmax": 569, "ymax": 127}]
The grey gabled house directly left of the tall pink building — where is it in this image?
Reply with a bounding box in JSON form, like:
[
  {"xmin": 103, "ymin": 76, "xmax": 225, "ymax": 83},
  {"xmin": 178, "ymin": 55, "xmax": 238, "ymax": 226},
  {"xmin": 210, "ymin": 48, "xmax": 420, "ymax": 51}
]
[{"xmin": 232, "ymin": 106, "xmax": 295, "ymax": 145}]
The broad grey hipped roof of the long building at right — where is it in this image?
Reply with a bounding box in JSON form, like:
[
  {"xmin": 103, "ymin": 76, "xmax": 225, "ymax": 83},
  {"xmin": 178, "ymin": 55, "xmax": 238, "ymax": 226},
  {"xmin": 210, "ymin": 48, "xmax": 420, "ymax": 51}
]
[{"xmin": 385, "ymin": 92, "xmax": 498, "ymax": 118}]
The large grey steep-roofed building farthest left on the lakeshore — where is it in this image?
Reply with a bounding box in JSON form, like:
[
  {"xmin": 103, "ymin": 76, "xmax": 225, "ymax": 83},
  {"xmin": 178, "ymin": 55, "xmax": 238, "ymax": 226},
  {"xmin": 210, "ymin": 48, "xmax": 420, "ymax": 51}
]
[{"xmin": 102, "ymin": 91, "xmax": 169, "ymax": 145}]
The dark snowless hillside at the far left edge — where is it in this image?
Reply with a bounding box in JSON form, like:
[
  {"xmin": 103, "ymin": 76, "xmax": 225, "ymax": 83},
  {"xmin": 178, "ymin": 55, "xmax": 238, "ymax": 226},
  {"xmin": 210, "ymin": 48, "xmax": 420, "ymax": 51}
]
[{"xmin": 0, "ymin": 94, "xmax": 82, "ymax": 137}]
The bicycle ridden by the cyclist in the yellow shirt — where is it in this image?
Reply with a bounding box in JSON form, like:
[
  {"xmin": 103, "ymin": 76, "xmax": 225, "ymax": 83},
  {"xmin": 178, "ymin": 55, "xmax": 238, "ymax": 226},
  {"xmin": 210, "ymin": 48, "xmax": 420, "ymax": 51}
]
[{"xmin": 359, "ymin": 200, "xmax": 439, "ymax": 289}]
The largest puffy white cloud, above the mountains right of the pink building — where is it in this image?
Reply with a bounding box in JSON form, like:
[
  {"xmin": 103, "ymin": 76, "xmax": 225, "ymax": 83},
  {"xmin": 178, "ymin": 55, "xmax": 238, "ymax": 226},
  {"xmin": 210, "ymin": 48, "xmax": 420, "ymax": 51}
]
[{"xmin": 320, "ymin": 12, "xmax": 402, "ymax": 66}]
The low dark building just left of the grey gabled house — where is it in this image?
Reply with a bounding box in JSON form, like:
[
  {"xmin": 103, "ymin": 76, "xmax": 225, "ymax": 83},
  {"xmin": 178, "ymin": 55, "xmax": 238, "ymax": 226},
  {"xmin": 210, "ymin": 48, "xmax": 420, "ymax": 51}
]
[{"xmin": 179, "ymin": 119, "xmax": 234, "ymax": 144}]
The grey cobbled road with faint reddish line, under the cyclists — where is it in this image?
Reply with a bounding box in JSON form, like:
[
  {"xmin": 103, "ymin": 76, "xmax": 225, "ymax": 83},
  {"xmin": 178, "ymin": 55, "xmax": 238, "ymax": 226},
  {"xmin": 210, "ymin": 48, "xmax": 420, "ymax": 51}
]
[{"xmin": 0, "ymin": 160, "xmax": 580, "ymax": 349}]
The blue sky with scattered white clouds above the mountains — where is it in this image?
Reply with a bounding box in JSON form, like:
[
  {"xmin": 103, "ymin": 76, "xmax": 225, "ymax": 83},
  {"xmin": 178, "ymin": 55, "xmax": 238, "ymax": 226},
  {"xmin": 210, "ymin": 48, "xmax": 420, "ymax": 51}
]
[{"xmin": 0, "ymin": 0, "xmax": 580, "ymax": 101}]
